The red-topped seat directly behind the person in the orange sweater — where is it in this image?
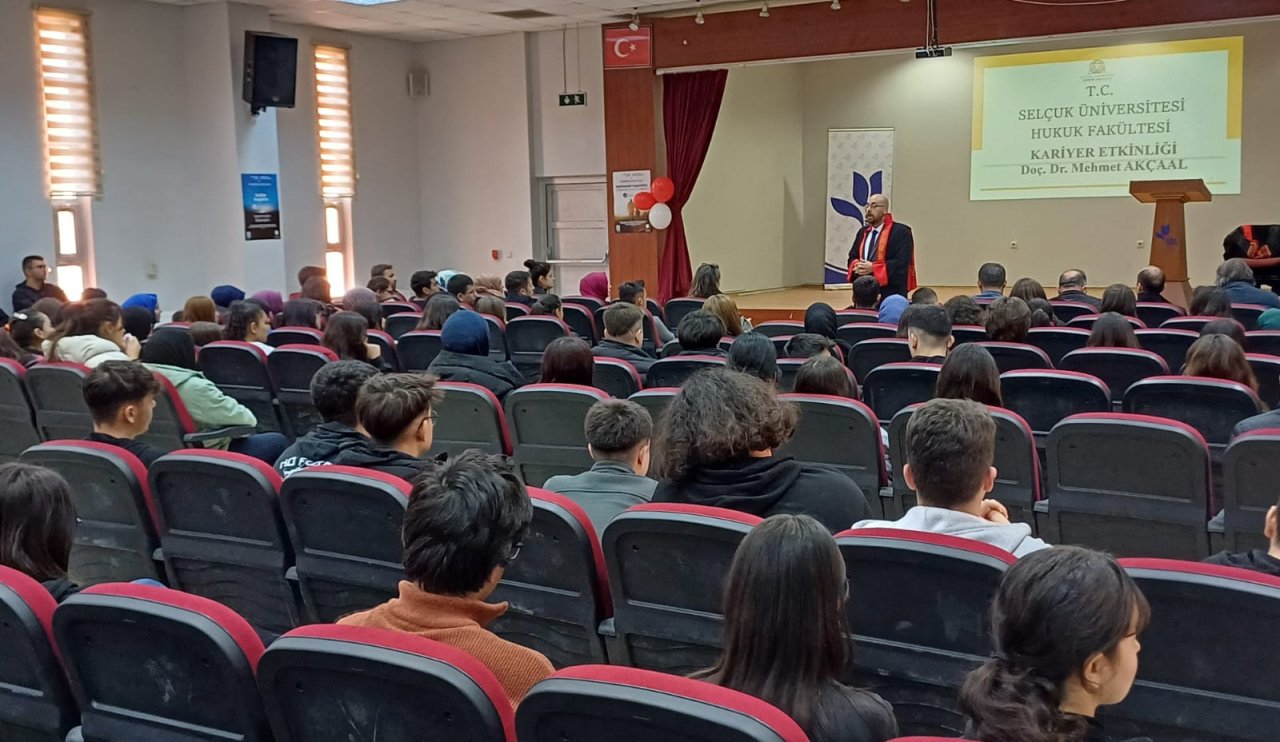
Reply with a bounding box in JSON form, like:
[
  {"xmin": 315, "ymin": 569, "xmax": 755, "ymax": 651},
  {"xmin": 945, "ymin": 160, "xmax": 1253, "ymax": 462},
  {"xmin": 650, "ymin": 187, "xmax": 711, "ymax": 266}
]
[{"xmin": 259, "ymin": 624, "xmax": 516, "ymax": 742}]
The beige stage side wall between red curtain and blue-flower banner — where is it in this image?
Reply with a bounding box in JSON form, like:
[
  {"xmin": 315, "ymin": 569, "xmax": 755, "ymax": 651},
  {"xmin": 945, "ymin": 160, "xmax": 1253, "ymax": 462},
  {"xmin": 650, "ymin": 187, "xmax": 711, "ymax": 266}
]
[{"xmin": 685, "ymin": 64, "xmax": 803, "ymax": 290}]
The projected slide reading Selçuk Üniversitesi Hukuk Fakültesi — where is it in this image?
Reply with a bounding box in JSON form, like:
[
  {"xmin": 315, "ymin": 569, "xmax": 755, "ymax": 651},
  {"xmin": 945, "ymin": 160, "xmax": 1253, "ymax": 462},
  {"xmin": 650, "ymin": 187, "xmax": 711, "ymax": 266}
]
[{"xmin": 969, "ymin": 37, "xmax": 1244, "ymax": 201}]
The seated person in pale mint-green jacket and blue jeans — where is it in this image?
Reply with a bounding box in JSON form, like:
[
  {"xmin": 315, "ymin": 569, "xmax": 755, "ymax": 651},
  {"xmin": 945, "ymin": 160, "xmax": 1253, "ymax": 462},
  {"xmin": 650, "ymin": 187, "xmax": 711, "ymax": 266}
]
[{"xmin": 140, "ymin": 333, "xmax": 288, "ymax": 464}]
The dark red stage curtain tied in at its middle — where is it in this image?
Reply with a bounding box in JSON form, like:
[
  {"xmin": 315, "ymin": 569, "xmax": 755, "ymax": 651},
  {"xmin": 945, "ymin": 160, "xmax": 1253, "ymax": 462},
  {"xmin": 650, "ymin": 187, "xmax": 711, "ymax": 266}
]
[{"xmin": 658, "ymin": 69, "xmax": 728, "ymax": 302}]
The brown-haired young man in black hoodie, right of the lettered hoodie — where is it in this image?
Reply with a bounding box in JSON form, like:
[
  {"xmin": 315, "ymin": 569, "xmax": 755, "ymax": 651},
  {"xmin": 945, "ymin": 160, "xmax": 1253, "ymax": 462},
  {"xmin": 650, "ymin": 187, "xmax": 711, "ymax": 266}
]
[{"xmin": 330, "ymin": 374, "xmax": 440, "ymax": 481}]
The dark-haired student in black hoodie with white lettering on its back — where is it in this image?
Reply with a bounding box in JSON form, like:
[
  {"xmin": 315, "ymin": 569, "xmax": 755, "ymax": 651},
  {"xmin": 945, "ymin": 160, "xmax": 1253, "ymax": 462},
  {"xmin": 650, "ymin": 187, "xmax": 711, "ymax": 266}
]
[{"xmin": 275, "ymin": 361, "xmax": 378, "ymax": 477}]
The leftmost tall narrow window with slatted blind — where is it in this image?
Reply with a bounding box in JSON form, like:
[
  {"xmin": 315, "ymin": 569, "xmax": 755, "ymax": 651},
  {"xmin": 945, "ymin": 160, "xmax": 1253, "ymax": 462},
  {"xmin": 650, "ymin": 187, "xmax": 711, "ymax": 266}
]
[{"xmin": 36, "ymin": 8, "xmax": 102, "ymax": 292}]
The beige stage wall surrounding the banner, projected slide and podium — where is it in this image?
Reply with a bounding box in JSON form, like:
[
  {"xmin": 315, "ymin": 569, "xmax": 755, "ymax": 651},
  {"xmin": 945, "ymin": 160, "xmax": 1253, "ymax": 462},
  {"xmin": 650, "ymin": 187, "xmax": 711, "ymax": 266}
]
[{"xmin": 686, "ymin": 20, "xmax": 1280, "ymax": 289}]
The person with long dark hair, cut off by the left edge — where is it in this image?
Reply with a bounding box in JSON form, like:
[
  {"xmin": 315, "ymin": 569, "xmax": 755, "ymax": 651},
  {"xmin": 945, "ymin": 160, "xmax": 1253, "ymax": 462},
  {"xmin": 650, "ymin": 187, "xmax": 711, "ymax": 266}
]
[{"xmin": 0, "ymin": 463, "xmax": 79, "ymax": 603}]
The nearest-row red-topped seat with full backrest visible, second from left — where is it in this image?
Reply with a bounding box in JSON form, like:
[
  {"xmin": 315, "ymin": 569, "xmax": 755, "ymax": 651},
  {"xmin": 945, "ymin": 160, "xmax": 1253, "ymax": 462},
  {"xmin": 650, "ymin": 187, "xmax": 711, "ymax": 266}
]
[{"xmin": 54, "ymin": 582, "xmax": 271, "ymax": 742}]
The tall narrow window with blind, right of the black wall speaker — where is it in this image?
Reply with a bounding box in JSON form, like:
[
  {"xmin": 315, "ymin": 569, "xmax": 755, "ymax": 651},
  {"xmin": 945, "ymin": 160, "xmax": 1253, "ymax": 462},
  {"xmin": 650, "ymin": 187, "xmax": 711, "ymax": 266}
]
[{"xmin": 315, "ymin": 45, "xmax": 356, "ymax": 296}]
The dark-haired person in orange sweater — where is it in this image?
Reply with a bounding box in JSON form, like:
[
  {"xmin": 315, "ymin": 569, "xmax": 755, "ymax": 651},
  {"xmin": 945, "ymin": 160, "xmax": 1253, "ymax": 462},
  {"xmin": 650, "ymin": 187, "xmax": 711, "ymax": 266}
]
[{"xmin": 338, "ymin": 450, "xmax": 554, "ymax": 707}]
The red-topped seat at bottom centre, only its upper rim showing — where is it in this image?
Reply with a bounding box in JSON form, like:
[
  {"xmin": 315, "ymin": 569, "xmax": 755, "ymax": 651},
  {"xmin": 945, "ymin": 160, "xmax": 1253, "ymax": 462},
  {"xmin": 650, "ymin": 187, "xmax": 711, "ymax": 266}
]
[{"xmin": 516, "ymin": 665, "xmax": 808, "ymax": 742}]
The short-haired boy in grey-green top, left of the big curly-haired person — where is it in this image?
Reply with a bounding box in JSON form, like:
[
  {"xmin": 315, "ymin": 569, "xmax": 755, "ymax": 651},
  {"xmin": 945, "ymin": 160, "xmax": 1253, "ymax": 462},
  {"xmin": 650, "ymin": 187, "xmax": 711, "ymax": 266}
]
[{"xmin": 543, "ymin": 399, "xmax": 658, "ymax": 536}]
